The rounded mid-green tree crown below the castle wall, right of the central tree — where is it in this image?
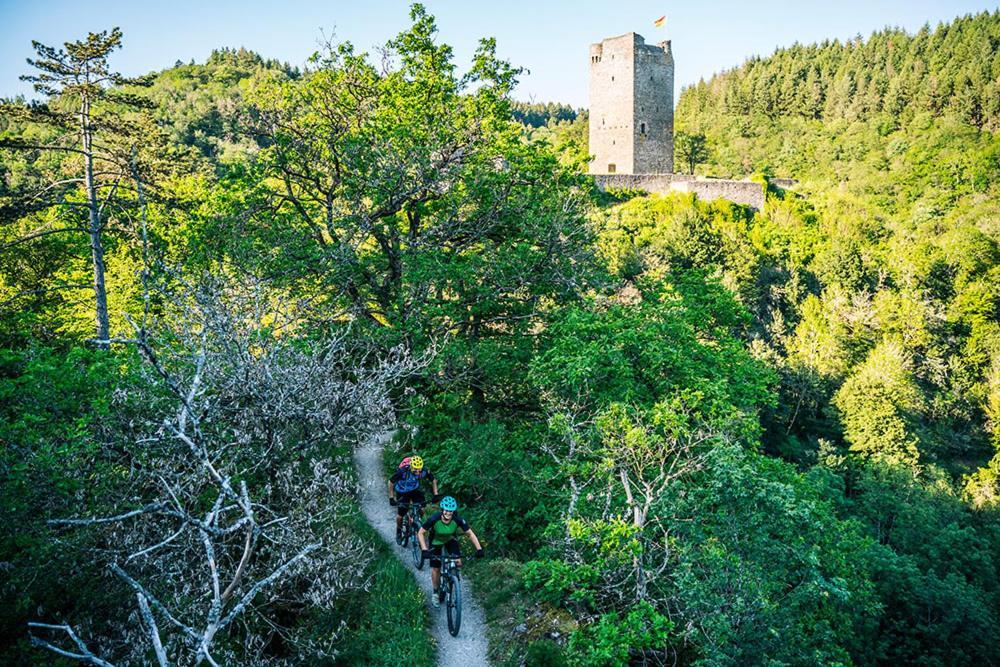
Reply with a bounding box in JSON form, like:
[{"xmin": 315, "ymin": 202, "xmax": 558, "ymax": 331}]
[{"xmin": 530, "ymin": 272, "xmax": 769, "ymax": 410}]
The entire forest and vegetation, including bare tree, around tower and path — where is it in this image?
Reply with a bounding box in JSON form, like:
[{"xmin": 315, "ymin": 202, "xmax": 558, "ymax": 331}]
[{"xmin": 0, "ymin": 5, "xmax": 1000, "ymax": 666}]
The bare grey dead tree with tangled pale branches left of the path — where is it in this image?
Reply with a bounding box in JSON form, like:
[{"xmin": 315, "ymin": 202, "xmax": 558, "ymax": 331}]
[{"xmin": 31, "ymin": 282, "xmax": 417, "ymax": 665}]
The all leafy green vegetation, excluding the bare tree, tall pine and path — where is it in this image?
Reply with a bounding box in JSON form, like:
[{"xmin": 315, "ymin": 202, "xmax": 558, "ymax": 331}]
[{"xmin": 0, "ymin": 5, "xmax": 1000, "ymax": 665}]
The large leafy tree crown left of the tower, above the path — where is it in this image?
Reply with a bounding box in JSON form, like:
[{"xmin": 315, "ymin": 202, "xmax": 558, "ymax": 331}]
[{"xmin": 247, "ymin": 5, "xmax": 584, "ymax": 350}]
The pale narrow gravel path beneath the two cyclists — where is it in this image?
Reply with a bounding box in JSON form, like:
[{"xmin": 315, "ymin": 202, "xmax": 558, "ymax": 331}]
[{"xmin": 354, "ymin": 434, "xmax": 489, "ymax": 667}]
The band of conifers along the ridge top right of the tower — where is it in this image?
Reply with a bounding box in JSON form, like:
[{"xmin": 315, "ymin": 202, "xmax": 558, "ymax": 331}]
[{"xmin": 679, "ymin": 11, "xmax": 1000, "ymax": 132}]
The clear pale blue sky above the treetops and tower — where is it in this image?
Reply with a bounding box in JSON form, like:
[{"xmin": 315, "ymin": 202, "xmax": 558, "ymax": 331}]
[{"xmin": 0, "ymin": 0, "xmax": 997, "ymax": 106}]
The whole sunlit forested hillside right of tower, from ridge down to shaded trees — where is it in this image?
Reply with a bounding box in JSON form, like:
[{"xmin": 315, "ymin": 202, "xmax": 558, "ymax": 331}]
[{"xmin": 678, "ymin": 13, "xmax": 1000, "ymax": 480}]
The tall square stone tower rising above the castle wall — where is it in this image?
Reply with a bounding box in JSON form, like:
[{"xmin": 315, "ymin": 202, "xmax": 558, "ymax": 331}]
[{"xmin": 590, "ymin": 32, "xmax": 674, "ymax": 174}]
